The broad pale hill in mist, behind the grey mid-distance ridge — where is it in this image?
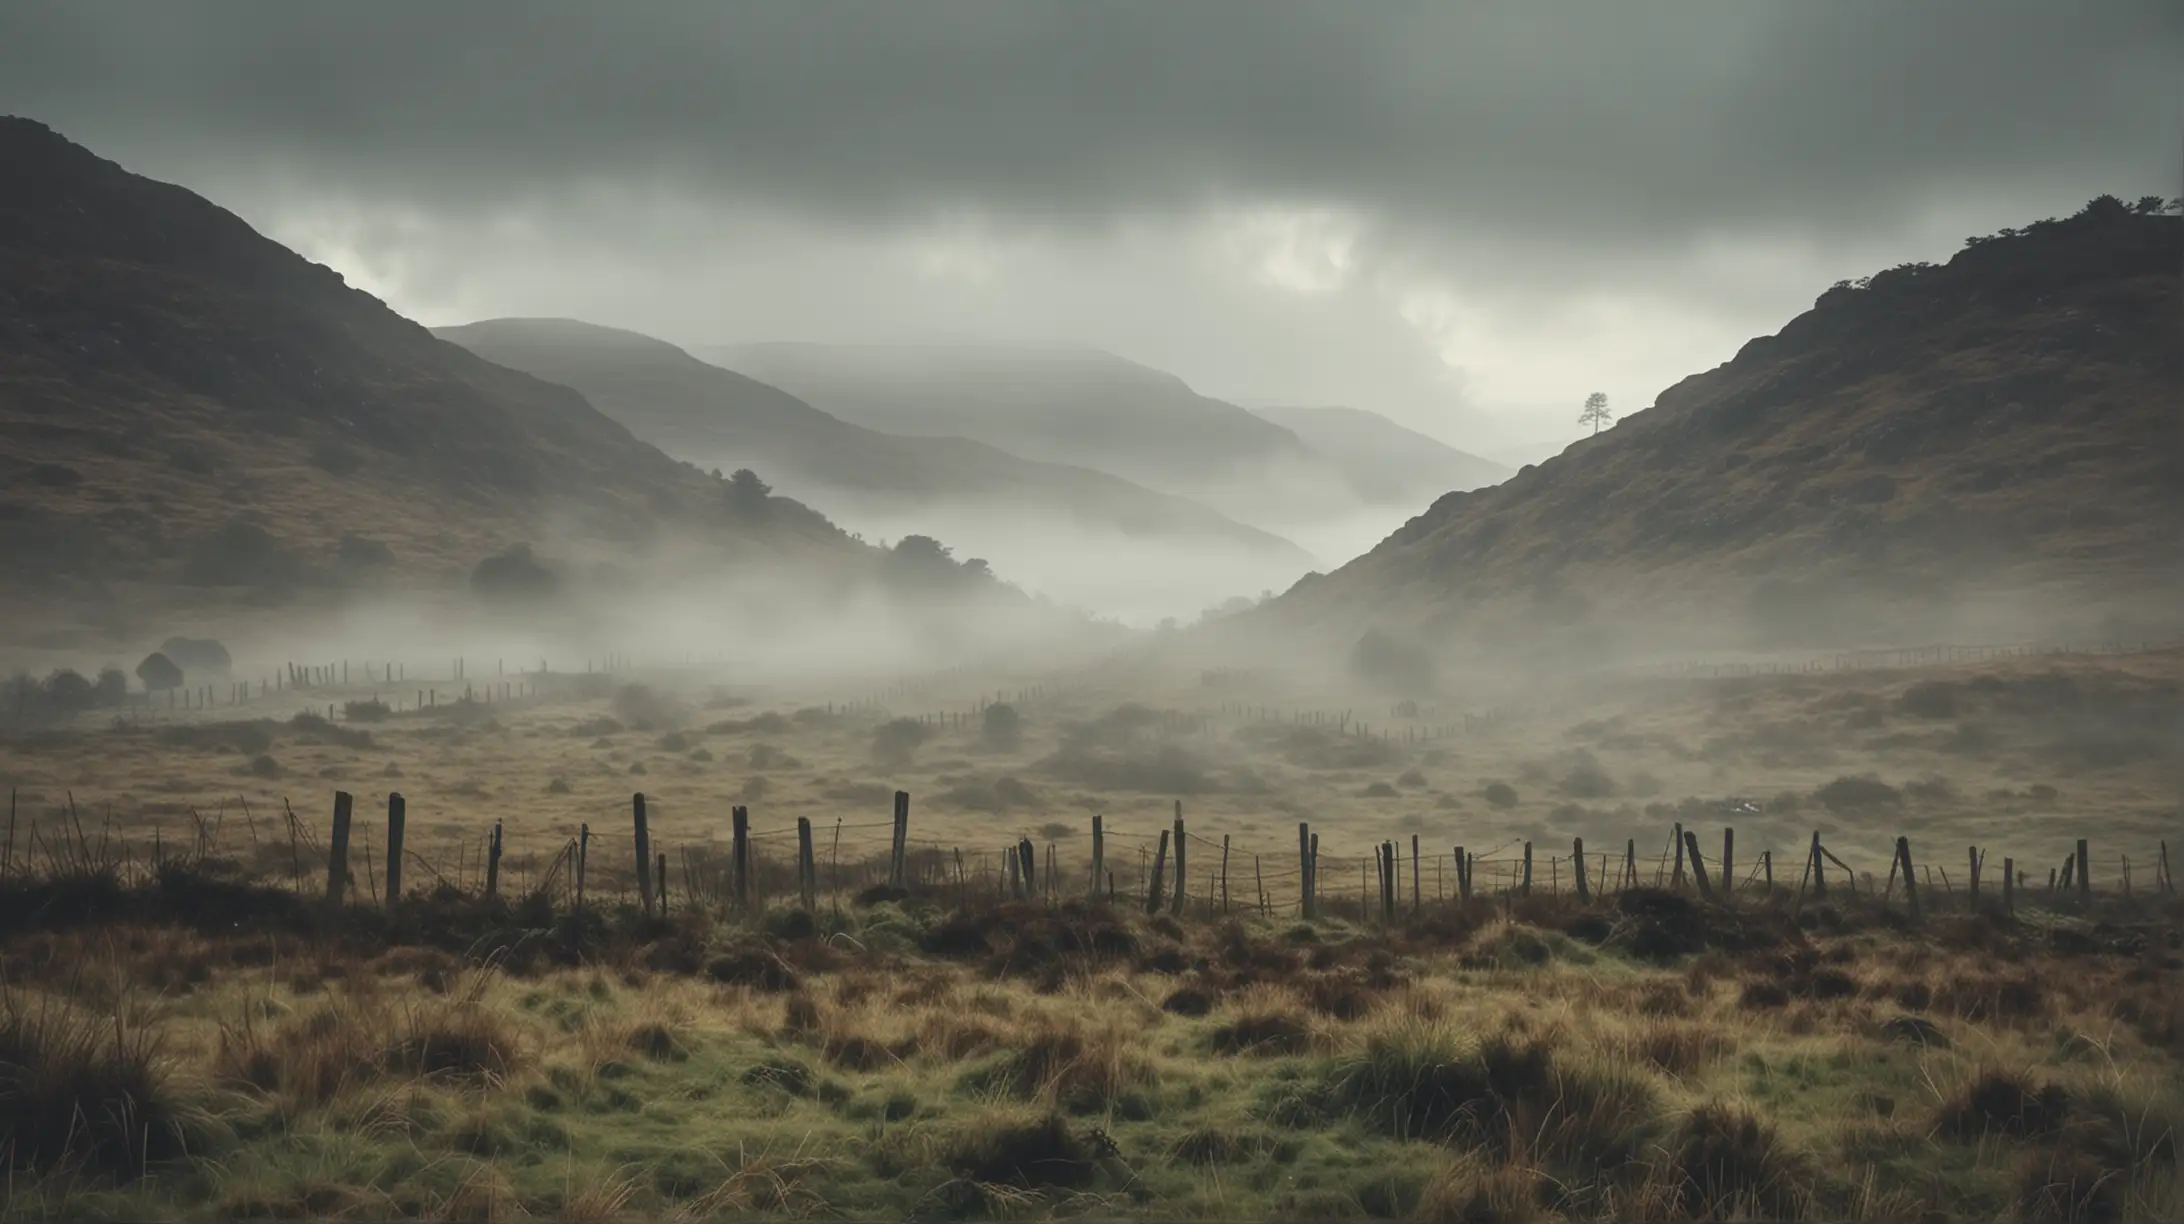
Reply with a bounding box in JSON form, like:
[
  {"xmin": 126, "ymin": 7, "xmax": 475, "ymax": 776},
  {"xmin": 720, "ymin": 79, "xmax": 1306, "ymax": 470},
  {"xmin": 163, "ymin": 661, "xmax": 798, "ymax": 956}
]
[{"xmin": 697, "ymin": 343, "xmax": 1358, "ymax": 531}]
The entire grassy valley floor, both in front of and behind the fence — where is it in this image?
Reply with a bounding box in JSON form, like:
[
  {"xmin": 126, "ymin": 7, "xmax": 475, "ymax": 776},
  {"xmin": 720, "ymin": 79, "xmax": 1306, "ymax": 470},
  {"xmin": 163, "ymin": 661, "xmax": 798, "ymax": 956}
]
[{"xmin": 0, "ymin": 654, "xmax": 2184, "ymax": 1222}]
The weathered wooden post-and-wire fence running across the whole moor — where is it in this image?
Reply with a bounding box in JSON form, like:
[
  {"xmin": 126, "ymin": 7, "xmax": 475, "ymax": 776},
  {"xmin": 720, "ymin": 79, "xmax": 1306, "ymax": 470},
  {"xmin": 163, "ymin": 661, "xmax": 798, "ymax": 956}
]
[{"xmin": 0, "ymin": 791, "xmax": 2175, "ymax": 925}]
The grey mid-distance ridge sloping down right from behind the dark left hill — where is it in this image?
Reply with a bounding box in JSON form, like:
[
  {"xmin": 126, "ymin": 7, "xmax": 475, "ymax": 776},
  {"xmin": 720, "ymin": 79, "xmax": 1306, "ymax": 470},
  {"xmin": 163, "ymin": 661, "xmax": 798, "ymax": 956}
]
[{"xmin": 437, "ymin": 319, "xmax": 1308, "ymax": 564}]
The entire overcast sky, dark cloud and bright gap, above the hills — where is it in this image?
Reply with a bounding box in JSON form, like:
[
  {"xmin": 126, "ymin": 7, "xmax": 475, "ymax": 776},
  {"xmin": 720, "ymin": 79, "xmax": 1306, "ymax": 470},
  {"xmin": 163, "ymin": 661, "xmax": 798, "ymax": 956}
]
[{"xmin": 0, "ymin": 0, "xmax": 2184, "ymax": 450}]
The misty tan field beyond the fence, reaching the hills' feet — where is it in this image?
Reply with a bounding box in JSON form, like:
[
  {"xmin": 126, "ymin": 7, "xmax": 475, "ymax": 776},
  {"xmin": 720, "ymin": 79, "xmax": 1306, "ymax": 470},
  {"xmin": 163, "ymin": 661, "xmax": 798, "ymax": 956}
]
[{"xmin": 0, "ymin": 651, "xmax": 2184, "ymax": 901}]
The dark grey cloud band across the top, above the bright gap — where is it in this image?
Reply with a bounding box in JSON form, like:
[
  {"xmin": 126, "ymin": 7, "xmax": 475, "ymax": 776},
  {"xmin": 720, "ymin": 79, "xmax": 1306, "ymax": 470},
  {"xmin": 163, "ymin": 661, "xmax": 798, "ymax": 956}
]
[{"xmin": 0, "ymin": 0, "xmax": 2184, "ymax": 245}]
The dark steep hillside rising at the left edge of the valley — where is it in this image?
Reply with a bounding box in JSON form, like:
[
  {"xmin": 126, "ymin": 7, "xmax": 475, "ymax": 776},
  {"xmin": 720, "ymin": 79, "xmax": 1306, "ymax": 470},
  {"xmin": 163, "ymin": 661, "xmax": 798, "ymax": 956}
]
[{"xmin": 0, "ymin": 118, "xmax": 874, "ymax": 586}]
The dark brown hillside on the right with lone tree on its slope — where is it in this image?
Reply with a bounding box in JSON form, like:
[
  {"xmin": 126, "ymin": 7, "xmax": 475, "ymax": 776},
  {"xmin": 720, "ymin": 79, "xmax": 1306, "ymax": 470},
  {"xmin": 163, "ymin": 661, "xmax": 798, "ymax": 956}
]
[{"xmin": 1260, "ymin": 197, "xmax": 2184, "ymax": 649}]
